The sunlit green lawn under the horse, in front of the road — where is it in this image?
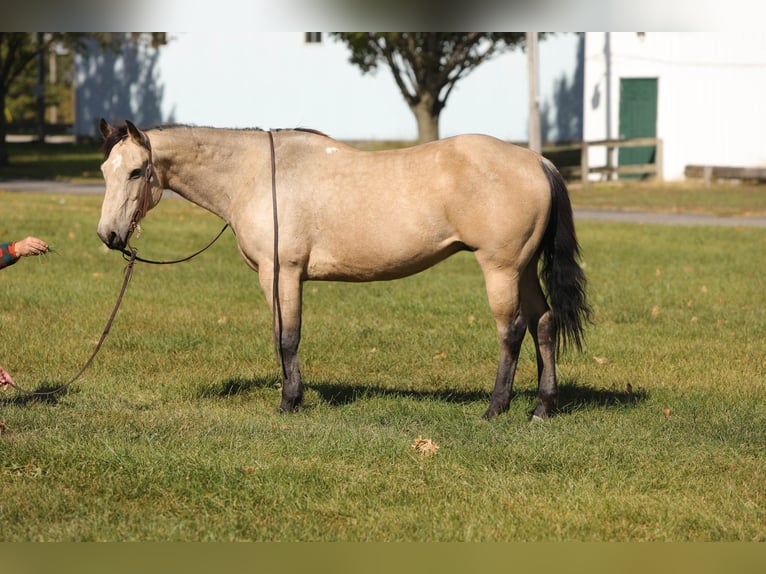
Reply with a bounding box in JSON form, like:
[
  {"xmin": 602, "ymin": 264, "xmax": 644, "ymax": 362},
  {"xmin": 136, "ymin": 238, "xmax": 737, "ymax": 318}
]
[{"xmin": 0, "ymin": 188, "xmax": 766, "ymax": 541}]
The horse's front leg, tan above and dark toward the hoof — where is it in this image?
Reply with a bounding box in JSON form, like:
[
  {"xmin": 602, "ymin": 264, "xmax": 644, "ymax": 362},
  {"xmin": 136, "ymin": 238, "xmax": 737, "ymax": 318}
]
[{"xmin": 261, "ymin": 271, "xmax": 303, "ymax": 413}]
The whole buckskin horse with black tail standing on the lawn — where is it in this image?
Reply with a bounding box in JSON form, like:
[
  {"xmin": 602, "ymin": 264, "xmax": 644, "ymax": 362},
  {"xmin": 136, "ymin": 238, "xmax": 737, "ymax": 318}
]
[{"xmin": 98, "ymin": 119, "xmax": 590, "ymax": 419}]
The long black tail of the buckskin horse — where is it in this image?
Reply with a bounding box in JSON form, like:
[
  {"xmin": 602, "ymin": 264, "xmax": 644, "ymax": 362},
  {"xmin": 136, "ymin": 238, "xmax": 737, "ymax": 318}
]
[{"xmin": 541, "ymin": 160, "xmax": 591, "ymax": 351}]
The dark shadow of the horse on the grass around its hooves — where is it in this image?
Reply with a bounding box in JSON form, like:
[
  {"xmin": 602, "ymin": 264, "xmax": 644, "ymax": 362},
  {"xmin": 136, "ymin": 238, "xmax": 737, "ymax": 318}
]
[{"xmin": 200, "ymin": 377, "xmax": 648, "ymax": 415}]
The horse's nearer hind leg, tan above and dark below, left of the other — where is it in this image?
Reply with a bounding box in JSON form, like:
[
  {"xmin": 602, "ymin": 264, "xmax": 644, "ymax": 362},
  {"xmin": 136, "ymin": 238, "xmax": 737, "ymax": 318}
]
[{"xmin": 480, "ymin": 268, "xmax": 526, "ymax": 419}]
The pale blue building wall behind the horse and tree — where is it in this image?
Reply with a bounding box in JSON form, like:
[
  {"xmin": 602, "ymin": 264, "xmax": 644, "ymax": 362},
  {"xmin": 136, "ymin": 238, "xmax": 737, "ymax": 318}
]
[{"xmin": 76, "ymin": 32, "xmax": 582, "ymax": 141}]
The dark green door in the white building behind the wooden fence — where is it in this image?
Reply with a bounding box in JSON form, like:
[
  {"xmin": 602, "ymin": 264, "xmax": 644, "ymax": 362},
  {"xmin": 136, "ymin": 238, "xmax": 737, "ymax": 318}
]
[{"xmin": 619, "ymin": 78, "xmax": 657, "ymax": 179}]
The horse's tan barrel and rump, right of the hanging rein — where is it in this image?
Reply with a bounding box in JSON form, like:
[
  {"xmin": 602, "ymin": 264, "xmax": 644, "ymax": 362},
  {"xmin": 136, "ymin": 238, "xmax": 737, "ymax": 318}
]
[{"xmin": 277, "ymin": 134, "xmax": 550, "ymax": 281}]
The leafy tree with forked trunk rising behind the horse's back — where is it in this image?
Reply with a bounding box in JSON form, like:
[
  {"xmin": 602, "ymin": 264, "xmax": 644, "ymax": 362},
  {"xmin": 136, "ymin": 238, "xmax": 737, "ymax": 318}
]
[{"xmin": 333, "ymin": 32, "xmax": 526, "ymax": 142}]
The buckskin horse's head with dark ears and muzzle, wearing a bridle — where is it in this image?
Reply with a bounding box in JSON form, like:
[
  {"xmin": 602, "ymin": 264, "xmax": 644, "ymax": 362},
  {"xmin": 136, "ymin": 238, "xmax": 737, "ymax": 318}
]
[{"xmin": 98, "ymin": 119, "xmax": 162, "ymax": 249}]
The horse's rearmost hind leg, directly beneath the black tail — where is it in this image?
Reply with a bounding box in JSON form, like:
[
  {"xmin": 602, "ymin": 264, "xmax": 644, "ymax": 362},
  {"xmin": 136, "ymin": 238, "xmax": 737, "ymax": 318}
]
[{"xmin": 521, "ymin": 263, "xmax": 558, "ymax": 419}]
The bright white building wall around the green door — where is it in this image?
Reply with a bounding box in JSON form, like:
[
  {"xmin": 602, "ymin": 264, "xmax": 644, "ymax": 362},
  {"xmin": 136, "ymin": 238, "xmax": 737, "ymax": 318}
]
[{"xmin": 583, "ymin": 32, "xmax": 766, "ymax": 180}]
